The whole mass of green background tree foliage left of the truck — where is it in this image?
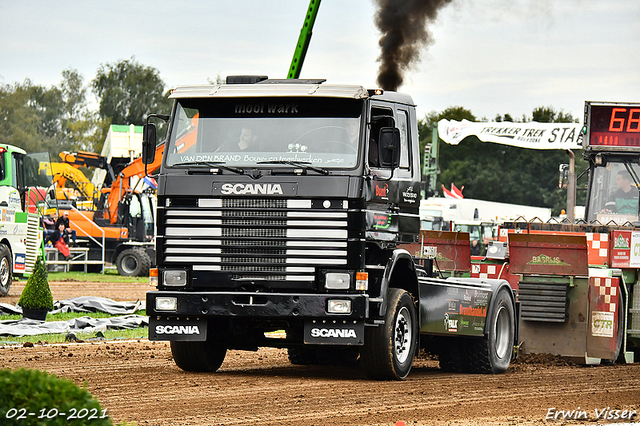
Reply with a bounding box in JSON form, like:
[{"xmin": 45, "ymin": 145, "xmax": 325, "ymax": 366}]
[{"xmin": 0, "ymin": 59, "xmax": 171, "ymax": 160}]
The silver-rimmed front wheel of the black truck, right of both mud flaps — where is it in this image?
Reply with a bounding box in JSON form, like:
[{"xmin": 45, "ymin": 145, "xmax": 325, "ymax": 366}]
[{"xmin": 360, "ymin": 288, "xmax": 418, "ymax": 380}]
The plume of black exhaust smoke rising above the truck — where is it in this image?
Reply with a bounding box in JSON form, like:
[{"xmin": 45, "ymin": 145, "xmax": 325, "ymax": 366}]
[{"xmin": 375, "ymin": 0, "xmax": 452, "ymax": 90}]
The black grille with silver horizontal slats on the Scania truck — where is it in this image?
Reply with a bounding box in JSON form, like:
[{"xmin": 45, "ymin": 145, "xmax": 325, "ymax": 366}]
[{"xmin": 163, "ymin": 198, "xmax": 348, "ymax": 281}]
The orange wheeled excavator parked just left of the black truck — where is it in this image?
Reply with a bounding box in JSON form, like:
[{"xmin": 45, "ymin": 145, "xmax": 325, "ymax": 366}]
[{"xmin": 53, "ymin": 144, "xmax": 164, "ymax": 276}]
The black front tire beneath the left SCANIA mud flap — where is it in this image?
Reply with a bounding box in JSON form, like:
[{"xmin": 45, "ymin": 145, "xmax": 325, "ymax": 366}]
[{"xmin": 171, "ymin": 337, "xmax": 227, "ymax": 372}]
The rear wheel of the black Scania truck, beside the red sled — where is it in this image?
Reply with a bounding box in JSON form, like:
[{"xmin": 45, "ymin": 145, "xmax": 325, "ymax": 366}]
[{"xmin": 465, "ymin": 288, "xmax": 515, "ymax": 374}]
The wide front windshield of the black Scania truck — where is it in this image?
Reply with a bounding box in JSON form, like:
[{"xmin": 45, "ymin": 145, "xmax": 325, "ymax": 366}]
[{"xmin": 166, "ymin": 98, "xmax": 363, "ymax": 169}]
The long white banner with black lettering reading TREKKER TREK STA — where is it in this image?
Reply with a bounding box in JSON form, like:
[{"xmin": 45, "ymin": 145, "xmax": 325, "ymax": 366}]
[{"xmin": 438, "ymin": 120, "xmax": 582, "ymax": 149}]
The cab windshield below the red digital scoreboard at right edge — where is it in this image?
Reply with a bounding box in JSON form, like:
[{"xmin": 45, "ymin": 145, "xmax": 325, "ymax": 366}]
[{"xmin": 587, "ymin": 161, "xmax": 640, "ymax": 225}]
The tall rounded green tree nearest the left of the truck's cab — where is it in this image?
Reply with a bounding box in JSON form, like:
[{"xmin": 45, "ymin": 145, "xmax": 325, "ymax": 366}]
[{"xmin": 92, "ymin": 57, "xmax": 171, "ymax": 126}]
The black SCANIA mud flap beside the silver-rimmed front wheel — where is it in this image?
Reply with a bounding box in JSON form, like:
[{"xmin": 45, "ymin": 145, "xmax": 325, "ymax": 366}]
[{"xmin": 304, "ymin": 320, "xmax": 364, "ymax": 345}]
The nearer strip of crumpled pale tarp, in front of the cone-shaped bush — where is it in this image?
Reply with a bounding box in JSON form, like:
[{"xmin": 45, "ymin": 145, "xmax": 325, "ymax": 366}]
[{"xmin": 0, "ymin": 315, "xmax": 149, "ymax": 336}]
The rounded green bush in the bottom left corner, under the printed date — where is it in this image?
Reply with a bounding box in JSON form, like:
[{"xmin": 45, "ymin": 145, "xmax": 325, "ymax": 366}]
[{"xmin": 0, "ymin": 368, "xmax": 113, "ymax": 426}]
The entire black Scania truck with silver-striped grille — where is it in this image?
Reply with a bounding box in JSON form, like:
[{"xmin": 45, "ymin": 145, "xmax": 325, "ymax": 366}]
[{"xmin": 143, "ymin": 76, "xmax": 517, "ymax": 379}]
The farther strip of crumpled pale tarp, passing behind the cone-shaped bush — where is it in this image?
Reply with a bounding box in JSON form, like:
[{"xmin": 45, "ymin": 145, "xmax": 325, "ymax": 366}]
[{"xmin": 0, "ymin": 296, "xmax": 146, "ymax": 315}]
